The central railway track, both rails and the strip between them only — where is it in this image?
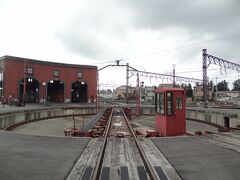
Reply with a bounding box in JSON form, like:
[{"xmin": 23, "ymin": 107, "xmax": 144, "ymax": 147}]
[{"xmin": 91, "ymin": 107, "xmax": 162, "ymax": 180}]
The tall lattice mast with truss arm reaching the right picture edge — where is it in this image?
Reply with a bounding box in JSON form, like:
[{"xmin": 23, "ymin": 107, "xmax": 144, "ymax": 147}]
[{"xmin": 202, "ymin": 49, "xmax": 240, "ymax": 102}]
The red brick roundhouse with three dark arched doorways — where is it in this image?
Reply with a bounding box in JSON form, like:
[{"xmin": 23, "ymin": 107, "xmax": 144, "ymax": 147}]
[{"xmin": 0, "ymin": 56, "xmax": 97, "ymax": 103}]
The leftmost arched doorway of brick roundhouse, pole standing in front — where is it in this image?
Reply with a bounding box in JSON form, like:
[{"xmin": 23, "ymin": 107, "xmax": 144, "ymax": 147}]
[{"xmin": 19, "ymin": 77, "xmax": 39, "ymax": 103}]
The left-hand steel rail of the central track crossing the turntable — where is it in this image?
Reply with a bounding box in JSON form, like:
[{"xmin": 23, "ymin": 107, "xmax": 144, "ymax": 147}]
[{"xmin": 91, "ymin": 107, "xmax": 114, "ymax": 180}]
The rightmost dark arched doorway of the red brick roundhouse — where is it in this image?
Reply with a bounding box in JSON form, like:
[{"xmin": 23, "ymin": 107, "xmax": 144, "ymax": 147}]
[{"xmin": 72, "ymin": 81, "xmax": 87, "ymax": 103}]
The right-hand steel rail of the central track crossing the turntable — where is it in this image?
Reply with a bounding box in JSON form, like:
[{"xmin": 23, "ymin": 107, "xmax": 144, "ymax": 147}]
[{"xmin": 121, "ymin": 108, "xmax": 159, "ymax": 180}]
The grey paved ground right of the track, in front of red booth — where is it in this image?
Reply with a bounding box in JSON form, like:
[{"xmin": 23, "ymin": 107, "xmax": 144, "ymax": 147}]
[{"xmin": 151, "ymin": 137, "xmax": 240, "ymax": 180}]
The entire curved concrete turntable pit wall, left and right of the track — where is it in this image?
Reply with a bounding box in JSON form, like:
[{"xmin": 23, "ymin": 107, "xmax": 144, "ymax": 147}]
[{"xmin": 0, "ymin": 107, "xmax": 240, "ymax": 129}]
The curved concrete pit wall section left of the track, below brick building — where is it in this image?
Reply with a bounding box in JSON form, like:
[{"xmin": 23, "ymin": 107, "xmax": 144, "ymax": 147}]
[{"xmin": 0, "ymin": 107, "xmax": 96, "ymax": 129}]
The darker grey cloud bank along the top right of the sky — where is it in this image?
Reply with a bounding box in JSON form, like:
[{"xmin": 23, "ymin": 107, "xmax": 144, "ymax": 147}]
[{"xmin": 122, "ymin": 0, "xmax": 240, "ymax": 32}]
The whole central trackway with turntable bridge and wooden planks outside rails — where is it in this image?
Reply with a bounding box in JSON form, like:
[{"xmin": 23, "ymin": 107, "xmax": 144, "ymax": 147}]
[{"xmin": 66, "ymin": 105, "xmax": 172, "ymax": 180}]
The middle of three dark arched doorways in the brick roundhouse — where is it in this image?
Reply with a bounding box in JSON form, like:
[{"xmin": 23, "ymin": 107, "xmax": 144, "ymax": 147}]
[{"xmin": 47, "ymin": 80, "xmax": 64, "ymax": 102}]
